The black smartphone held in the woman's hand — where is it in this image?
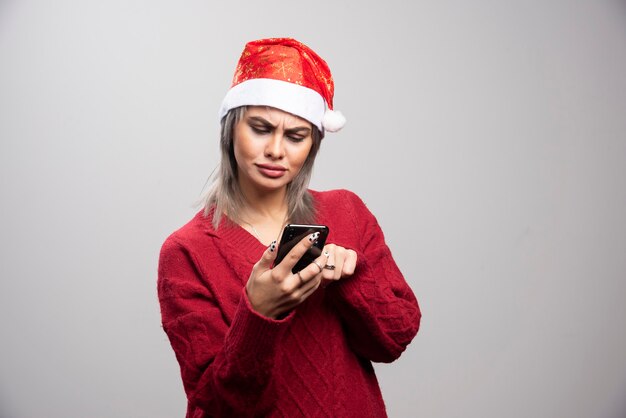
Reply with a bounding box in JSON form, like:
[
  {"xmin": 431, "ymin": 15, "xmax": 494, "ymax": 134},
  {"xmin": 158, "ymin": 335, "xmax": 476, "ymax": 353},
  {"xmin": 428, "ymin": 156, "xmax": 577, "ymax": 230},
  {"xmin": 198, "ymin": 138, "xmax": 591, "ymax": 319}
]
[{"xmin": 274, "ymin": 224, "xmax": 328, "ymax": 274}]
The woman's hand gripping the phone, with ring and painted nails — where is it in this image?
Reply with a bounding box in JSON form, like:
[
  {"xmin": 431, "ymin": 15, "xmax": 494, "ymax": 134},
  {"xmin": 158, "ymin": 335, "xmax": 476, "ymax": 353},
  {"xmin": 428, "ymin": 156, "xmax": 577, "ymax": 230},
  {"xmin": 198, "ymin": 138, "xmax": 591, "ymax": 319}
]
[{"xmin": 246, "ymin": 232, "xmax": 327, "ymax": 319}]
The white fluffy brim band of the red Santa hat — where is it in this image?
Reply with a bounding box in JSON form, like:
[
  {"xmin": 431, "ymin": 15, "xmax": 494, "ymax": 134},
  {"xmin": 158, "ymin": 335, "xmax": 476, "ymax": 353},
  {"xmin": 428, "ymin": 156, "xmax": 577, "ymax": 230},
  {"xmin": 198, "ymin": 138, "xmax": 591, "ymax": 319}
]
[{"xmin": 219, "ymin": 78, "xmax": 324, "ymax": 132}]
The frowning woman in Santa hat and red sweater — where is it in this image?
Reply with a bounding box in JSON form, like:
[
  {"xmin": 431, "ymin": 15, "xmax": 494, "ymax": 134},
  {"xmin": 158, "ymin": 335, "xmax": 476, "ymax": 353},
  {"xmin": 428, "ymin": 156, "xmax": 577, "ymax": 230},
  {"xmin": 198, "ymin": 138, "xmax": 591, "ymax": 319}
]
[{"xmin": 158, "ymin": 39, "xmax": 421, "ymax": 418}]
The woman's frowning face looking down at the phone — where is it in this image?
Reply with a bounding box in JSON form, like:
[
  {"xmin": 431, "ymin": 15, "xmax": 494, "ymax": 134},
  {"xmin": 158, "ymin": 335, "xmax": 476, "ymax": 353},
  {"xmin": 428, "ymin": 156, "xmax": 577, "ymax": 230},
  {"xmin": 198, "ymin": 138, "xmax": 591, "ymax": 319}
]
[{"xmin": 234, "ymin": 106, "xmax": 313, "ymax": 192}]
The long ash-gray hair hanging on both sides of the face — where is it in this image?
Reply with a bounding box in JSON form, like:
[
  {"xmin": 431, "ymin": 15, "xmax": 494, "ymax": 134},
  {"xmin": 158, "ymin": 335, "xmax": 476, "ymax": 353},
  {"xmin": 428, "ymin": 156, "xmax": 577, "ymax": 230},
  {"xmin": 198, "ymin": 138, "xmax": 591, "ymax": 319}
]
[{"xmin": 204, "ymin": 106, "xmax": 323, "ymax": 229}]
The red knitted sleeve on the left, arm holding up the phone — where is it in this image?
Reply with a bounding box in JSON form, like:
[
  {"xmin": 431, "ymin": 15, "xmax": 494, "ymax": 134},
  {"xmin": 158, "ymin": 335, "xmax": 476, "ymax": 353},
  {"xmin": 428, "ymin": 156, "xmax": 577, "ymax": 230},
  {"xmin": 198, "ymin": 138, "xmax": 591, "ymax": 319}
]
[{"xmin": 158, "ymin": 237, "xmax": 291, "ymax": 417}]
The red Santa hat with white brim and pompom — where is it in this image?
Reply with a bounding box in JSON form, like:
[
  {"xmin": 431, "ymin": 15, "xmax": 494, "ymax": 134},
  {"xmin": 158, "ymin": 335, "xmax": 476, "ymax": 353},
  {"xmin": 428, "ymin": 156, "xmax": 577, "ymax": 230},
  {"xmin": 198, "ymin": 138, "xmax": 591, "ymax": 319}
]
[{"xmin": 219, "ymin": 38, "xmax": 346, "ymax": 132}]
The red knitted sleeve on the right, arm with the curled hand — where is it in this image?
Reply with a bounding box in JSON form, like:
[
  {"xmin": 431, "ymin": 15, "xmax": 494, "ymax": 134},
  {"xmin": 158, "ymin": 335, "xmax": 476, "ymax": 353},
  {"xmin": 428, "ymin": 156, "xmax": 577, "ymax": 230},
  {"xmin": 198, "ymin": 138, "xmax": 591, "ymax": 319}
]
[{"xmin": 328, "ymin": 192, "xmax": 421, "ymax": 362}]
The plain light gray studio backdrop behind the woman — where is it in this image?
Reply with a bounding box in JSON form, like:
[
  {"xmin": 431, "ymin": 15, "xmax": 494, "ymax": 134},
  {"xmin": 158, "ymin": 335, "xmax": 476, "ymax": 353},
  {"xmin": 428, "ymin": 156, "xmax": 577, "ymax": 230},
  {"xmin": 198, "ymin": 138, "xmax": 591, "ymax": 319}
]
[{"xmin": 0, "ymin": 0, "xmax": 626, "ymax": 418}]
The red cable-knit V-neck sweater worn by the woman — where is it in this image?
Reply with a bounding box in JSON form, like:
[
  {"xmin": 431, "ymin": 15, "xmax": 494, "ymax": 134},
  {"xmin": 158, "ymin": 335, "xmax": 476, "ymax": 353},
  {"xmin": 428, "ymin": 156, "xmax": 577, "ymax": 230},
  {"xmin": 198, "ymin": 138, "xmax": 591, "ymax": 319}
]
[{"xmin": 158, "ymin": 190, "xmax": 421, "ymax": 418}]
